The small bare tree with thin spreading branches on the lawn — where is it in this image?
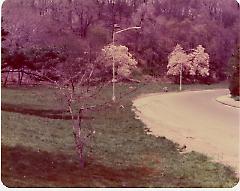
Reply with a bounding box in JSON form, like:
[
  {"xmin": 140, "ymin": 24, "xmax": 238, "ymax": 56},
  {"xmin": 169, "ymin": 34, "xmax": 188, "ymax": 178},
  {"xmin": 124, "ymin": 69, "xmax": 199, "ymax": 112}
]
[{"xmin": 27, "ymin": 44, "xmax": 142, "ymax": 167}]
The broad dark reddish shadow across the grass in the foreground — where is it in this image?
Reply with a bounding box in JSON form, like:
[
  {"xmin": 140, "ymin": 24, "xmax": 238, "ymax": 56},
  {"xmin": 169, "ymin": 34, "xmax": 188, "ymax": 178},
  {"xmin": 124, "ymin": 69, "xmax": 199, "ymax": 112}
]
[{"xmin": 1, "ymin": 145, "xmax": 152, "ymax": 187}]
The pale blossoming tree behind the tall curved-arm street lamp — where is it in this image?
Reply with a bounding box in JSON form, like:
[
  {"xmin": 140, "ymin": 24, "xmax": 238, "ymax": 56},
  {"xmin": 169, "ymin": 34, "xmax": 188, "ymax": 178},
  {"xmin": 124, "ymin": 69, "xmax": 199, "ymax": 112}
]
[{"xmin": 100, "ymin": 45, "xmax": 137, "ymax": 78}]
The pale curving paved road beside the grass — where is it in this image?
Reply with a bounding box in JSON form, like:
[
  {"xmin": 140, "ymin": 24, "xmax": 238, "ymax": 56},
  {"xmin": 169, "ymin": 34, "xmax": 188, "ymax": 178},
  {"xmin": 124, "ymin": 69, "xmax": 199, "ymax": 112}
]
[{"xmin": 134, "ymin": 89, "xmax": 240, "ymax": 172}]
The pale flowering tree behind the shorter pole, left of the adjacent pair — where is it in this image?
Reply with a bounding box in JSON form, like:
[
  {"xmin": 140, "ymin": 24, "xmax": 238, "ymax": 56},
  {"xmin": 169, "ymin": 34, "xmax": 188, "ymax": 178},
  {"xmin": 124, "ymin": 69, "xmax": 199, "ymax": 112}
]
[{"xmin": 167, "ymin": 44, "xmax": 191, "ymax": 91}]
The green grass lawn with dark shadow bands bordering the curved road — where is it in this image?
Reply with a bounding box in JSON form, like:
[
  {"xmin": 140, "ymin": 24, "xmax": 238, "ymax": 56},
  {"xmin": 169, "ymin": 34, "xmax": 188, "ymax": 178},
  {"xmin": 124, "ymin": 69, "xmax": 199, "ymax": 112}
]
[{"xmin": 1, "ymin": 82, "xmax": 238, "ymax": 187}]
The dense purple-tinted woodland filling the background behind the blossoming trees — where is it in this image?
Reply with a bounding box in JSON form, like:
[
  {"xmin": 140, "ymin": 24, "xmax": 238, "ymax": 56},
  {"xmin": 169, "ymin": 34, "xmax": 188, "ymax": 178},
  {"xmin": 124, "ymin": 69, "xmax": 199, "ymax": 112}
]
[{"xmin": 1, "ymin": 0, "xmax": 240, "ymax": 83}]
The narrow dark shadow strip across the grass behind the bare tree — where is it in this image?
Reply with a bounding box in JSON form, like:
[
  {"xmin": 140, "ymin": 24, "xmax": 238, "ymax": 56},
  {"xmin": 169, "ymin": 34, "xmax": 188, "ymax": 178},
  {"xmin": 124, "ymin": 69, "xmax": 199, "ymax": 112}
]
[{"xmin": 1, "ymin": 103, "xmax": 93, "ymax": 120}]
